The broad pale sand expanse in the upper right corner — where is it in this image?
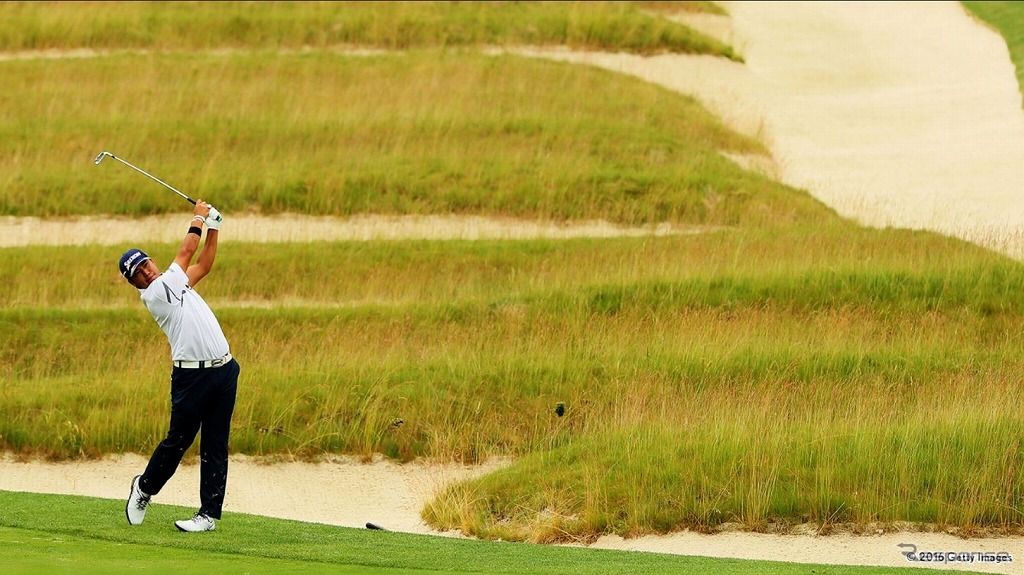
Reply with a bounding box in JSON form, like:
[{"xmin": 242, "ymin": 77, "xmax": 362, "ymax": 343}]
[{"xmin": 521, "ymin": 2, "xmax": 1024, "ymax": 258}]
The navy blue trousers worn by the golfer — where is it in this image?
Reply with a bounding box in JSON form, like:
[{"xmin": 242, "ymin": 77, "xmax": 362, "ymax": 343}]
[{"xmin": 139, "ymin": 359, "xmax": 241, "ymax": 519}]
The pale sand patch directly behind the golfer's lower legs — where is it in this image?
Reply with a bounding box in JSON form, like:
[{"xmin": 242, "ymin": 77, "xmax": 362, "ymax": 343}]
[{"xmin": 0, "ymin": 454, "xmax": 505, "ymax": 534}]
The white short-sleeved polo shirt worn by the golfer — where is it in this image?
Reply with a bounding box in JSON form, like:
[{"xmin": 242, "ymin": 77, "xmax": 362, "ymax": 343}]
[{"xmin": 138, "ymin": 263, "xmax": 229, "ymax": 361}]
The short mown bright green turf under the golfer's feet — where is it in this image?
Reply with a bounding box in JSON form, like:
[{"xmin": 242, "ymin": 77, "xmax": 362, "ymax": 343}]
[{"xmin": 0, "ymin": 491, "xmax": 950, "ymax": 575}]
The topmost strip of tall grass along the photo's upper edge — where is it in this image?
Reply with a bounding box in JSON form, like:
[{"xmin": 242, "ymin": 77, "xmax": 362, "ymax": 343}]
[{"xmin": 0, "ymin": 2, "xmax": 738, "ymax": 59}]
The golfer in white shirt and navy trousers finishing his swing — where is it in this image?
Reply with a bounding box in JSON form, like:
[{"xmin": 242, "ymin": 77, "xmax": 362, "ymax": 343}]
[{"xmin": 118, "ymin": 200, "xmax": 239, "ymax": 532}]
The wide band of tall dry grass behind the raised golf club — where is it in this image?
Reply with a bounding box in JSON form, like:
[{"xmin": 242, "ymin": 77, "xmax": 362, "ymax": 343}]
[{"xmin": 0, "ymin": 52, "xmax": 798, "ymax": 225}]
